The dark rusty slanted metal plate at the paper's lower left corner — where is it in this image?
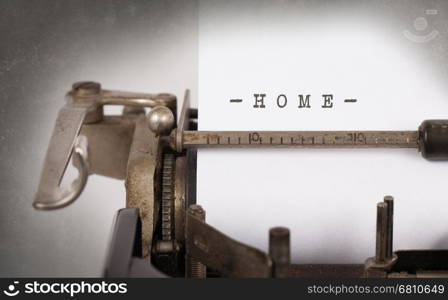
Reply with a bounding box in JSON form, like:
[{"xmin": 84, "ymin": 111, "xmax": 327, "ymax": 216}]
[{"xmin": 185, "ymin": 204, "xmax": 272, "ymax": 278}]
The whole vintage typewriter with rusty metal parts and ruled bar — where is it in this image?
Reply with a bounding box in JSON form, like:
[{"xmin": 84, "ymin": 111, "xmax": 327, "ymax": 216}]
[{"xmin": 33, "ymin": 82, "xmax": 448, "ymax": 278}]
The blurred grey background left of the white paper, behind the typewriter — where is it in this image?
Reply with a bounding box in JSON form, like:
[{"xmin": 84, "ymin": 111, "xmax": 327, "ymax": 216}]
[{"xmin": 0, "ymin": 0, "xmax": 197, "ymax": 276}]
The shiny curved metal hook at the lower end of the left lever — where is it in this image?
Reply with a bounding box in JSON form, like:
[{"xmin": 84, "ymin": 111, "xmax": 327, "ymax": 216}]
[{"xmin": 33, "ymin": 135, "xmax": 89, "ymax": 210}]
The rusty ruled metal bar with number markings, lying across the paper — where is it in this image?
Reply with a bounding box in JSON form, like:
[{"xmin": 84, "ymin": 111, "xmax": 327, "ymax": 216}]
[{"xmin": 169, "ymin": 129, "xmax": 419, "ymax": 151}]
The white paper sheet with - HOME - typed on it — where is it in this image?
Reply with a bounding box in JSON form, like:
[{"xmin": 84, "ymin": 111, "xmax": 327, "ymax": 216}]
[{"xmin": 197, "ymin": 2, "xmax": 448, "ymax": 263}]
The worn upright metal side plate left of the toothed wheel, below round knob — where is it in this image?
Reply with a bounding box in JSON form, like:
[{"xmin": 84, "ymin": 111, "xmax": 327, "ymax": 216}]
[{"xmin": 125, "ymin": 115, "xmax": 161, "ymax": 257}]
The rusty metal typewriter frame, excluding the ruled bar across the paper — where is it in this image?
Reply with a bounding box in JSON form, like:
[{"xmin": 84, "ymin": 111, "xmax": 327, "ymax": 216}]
[{"xmin": 35, "ymin": 82, "xmax": 448, "ymax": 278}]
